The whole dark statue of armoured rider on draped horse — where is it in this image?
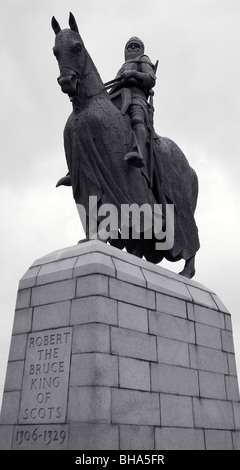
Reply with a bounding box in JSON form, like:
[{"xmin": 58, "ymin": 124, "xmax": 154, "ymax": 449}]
[{"xmin": 52, "ymin": 13, "xmax": 200, "ymax": 278}]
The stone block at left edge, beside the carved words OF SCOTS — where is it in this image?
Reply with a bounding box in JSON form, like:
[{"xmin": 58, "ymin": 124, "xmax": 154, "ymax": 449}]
[{"xmin": 0, "ymin": 391, "xmax": 21, "ymax": 424}]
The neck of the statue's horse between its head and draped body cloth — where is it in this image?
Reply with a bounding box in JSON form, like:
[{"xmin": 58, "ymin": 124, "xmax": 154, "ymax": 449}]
[{"xmin": 72, "ymin": 50, "xmax": 109, "ymax": 109}]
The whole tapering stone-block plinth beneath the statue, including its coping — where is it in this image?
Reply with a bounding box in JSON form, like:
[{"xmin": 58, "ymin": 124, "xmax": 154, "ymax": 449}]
[{"xmin": 0, "ymin": 241, "xmax": 240, "ymax": 450}]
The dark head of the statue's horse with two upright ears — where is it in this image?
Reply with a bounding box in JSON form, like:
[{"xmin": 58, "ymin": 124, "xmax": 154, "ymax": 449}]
[{"xmin": 52, "ymin": 13, "xmax": 86, "ymax": 97}]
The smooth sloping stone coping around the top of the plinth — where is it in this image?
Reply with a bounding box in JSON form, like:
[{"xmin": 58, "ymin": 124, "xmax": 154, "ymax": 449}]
[{"xmin": 19, "ymin": 240, "xmax": 229, "ymax": 314}]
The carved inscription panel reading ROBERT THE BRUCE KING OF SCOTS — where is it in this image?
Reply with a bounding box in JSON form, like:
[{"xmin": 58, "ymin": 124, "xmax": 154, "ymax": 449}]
[{"xmin": 19, "ymin": 327, "xmax": 72, "ymax": 424}]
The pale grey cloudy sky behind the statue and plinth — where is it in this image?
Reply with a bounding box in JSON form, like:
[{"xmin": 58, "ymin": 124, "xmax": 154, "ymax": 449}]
[{"xmin": 0, "ymin": 0, "xmax": 240, "ymax": 404}]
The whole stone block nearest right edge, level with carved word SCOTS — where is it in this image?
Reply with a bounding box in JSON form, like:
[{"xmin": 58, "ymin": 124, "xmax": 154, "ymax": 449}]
[{"xmin": 193, "ymin": 397, "xmax": 234, "ymax": 430}]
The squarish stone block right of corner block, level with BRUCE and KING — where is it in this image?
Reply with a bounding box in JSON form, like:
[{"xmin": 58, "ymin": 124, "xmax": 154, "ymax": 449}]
[{"xmin": 119, "ymin": 357, "xmax": 150, "ymax": 390}]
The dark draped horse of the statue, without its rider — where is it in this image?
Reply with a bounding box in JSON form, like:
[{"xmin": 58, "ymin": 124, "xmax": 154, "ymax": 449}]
[{"xmin": 52, "ymin": 13, "xmax": 199, "ymax": 278}]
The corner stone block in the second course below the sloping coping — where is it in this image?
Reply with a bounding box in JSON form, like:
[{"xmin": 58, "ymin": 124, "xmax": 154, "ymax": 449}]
[{"xmin": 71, "ymin": 295, "xmax": 118, "ymax": 325}]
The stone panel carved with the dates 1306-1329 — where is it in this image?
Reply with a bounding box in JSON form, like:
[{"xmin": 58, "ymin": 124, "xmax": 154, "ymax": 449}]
[{"xmin": 13, "ymin": 424, "xmax": 68, "ymax": 450}]
